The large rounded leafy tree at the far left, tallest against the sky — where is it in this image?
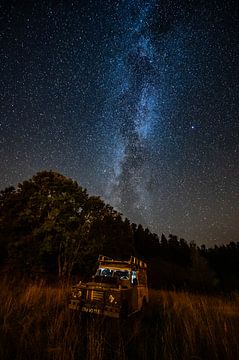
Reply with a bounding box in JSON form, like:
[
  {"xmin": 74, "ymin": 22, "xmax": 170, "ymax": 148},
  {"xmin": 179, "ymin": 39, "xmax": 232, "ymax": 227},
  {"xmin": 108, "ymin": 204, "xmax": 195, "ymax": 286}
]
[{"xmin": 0, "ymin": 171, "xmax": 88, "ymax": 276}]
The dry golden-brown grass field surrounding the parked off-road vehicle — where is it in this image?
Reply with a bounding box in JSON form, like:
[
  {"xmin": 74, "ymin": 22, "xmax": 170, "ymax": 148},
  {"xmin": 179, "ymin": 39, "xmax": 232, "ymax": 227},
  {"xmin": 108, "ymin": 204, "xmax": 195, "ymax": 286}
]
[{"xmin": 0, "ymin": 278, "xmax": 239, "ymax": 360}]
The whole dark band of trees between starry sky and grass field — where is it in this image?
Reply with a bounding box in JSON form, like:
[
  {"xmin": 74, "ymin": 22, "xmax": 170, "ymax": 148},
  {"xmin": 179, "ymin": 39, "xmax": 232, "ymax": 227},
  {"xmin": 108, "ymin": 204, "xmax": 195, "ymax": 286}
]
[{"xmin": 0, "ymin": 171, "xmax": 239, "ymax": 291}]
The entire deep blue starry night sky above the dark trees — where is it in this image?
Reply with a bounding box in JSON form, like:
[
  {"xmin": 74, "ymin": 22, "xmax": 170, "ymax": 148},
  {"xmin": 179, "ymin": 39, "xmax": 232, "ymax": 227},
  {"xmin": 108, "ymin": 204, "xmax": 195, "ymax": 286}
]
[{"xmin": 0, "ymin": 0, "xmax": 239, "ymax": 246}]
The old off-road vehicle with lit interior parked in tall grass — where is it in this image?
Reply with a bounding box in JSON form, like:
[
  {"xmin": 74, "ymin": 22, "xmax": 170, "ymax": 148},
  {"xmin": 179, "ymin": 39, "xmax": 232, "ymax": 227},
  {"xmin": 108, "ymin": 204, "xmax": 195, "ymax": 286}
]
[{"xmin": 69, "ymin": 255, "xmax": 149, "ymax": 318}]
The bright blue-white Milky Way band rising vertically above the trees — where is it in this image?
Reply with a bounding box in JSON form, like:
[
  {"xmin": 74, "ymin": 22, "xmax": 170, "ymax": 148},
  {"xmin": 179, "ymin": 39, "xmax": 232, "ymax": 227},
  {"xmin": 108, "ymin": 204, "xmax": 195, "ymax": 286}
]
[{"xmin": 106, "ymin": 1, "xmax": 158, "ymax": 224}]
